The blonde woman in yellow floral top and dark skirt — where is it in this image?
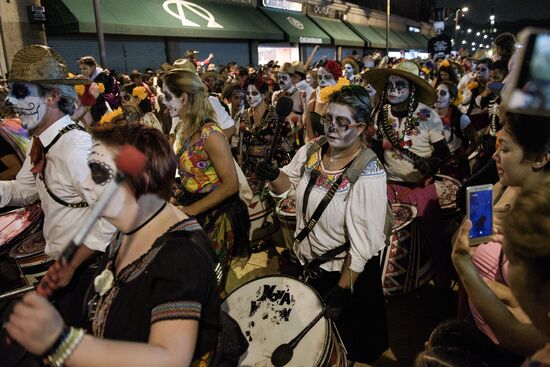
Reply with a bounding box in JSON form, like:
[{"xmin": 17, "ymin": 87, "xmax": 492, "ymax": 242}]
[{"xmin": 163, "ymin": 69, "xmax": 250, "ymax": 289}]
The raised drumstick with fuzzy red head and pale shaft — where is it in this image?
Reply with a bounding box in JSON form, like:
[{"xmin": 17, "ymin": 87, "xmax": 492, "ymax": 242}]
[{"xmin": 36, "ymin": 144, "xmax": 146, "ymax": 297}]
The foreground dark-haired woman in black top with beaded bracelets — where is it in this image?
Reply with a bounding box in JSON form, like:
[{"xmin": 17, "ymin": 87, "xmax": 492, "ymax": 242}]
[{"xmin": 7, "ymin": 120, "xmax": 220, "ymax": 367}]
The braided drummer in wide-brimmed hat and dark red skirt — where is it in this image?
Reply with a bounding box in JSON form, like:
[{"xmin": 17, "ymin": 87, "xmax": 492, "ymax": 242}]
[{"xmin": 363, "ymin": 62, "xmax": 452, "ymax": 288}]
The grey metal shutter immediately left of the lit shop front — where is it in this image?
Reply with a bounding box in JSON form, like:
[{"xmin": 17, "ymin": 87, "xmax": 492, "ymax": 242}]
[{"xmin": 178, "ymin": 40, "xmax": 250, "ymax": 66}]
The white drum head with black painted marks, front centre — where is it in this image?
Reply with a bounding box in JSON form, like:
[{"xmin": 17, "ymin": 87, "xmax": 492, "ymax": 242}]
[{"xmin": 222, "ymin": 276, "xmax": 330, "ymax": 367}]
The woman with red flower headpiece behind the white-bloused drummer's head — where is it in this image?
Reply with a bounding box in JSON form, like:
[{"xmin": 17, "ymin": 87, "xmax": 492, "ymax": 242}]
[{"xmin": 304, "ymin": 60, "xmax": 342, "ymax": 141}]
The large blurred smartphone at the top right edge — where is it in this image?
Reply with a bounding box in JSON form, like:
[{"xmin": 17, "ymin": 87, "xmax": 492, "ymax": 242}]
[{"xmin": 503, "ymin": 28, "xmax": 550, "ymax": 116}]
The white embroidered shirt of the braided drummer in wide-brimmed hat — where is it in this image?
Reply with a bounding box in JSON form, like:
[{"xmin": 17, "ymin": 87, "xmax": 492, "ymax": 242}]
[{"xmin": 376, "ymin": 102, "xmax": 445, "ymax": 182}]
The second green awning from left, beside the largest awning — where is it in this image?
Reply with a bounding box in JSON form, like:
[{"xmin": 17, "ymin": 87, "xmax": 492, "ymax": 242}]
[{"xmin": 261, "ymin": 8, "xmax": 330, "ymax": 45}]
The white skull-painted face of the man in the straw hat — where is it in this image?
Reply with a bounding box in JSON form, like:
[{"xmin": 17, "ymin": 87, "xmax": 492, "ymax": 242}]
[{"xmin": 6, "ymin": 83, "xmax": 47, "ymax": 130}]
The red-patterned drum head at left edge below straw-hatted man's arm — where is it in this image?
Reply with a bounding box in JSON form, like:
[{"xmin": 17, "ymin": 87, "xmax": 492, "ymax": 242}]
[{"xmin": 0, "ymin": 204, "xmax": 42, "ymax": 252}]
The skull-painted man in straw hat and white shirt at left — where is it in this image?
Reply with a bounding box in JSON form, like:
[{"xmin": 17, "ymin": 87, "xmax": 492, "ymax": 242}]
[{"xmin": 0, "ymin": 45, "xmax": 114, "ymax": 323}]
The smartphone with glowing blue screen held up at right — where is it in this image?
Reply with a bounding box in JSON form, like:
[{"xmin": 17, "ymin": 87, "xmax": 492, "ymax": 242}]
[{"xmin": 466, "ymin": 184, "xmax": 493, "ymax": 245}]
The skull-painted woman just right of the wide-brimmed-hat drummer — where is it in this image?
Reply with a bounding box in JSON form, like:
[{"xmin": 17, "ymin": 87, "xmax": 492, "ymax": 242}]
[{"xmin": 434, "ymin": 80, "xmax": 479, "ymax": 181}]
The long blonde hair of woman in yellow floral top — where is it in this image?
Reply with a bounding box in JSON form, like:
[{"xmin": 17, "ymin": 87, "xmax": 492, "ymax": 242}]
[{"xmin": 163, "ymin": 69, "xmax": 216, "ymax": 150}]
